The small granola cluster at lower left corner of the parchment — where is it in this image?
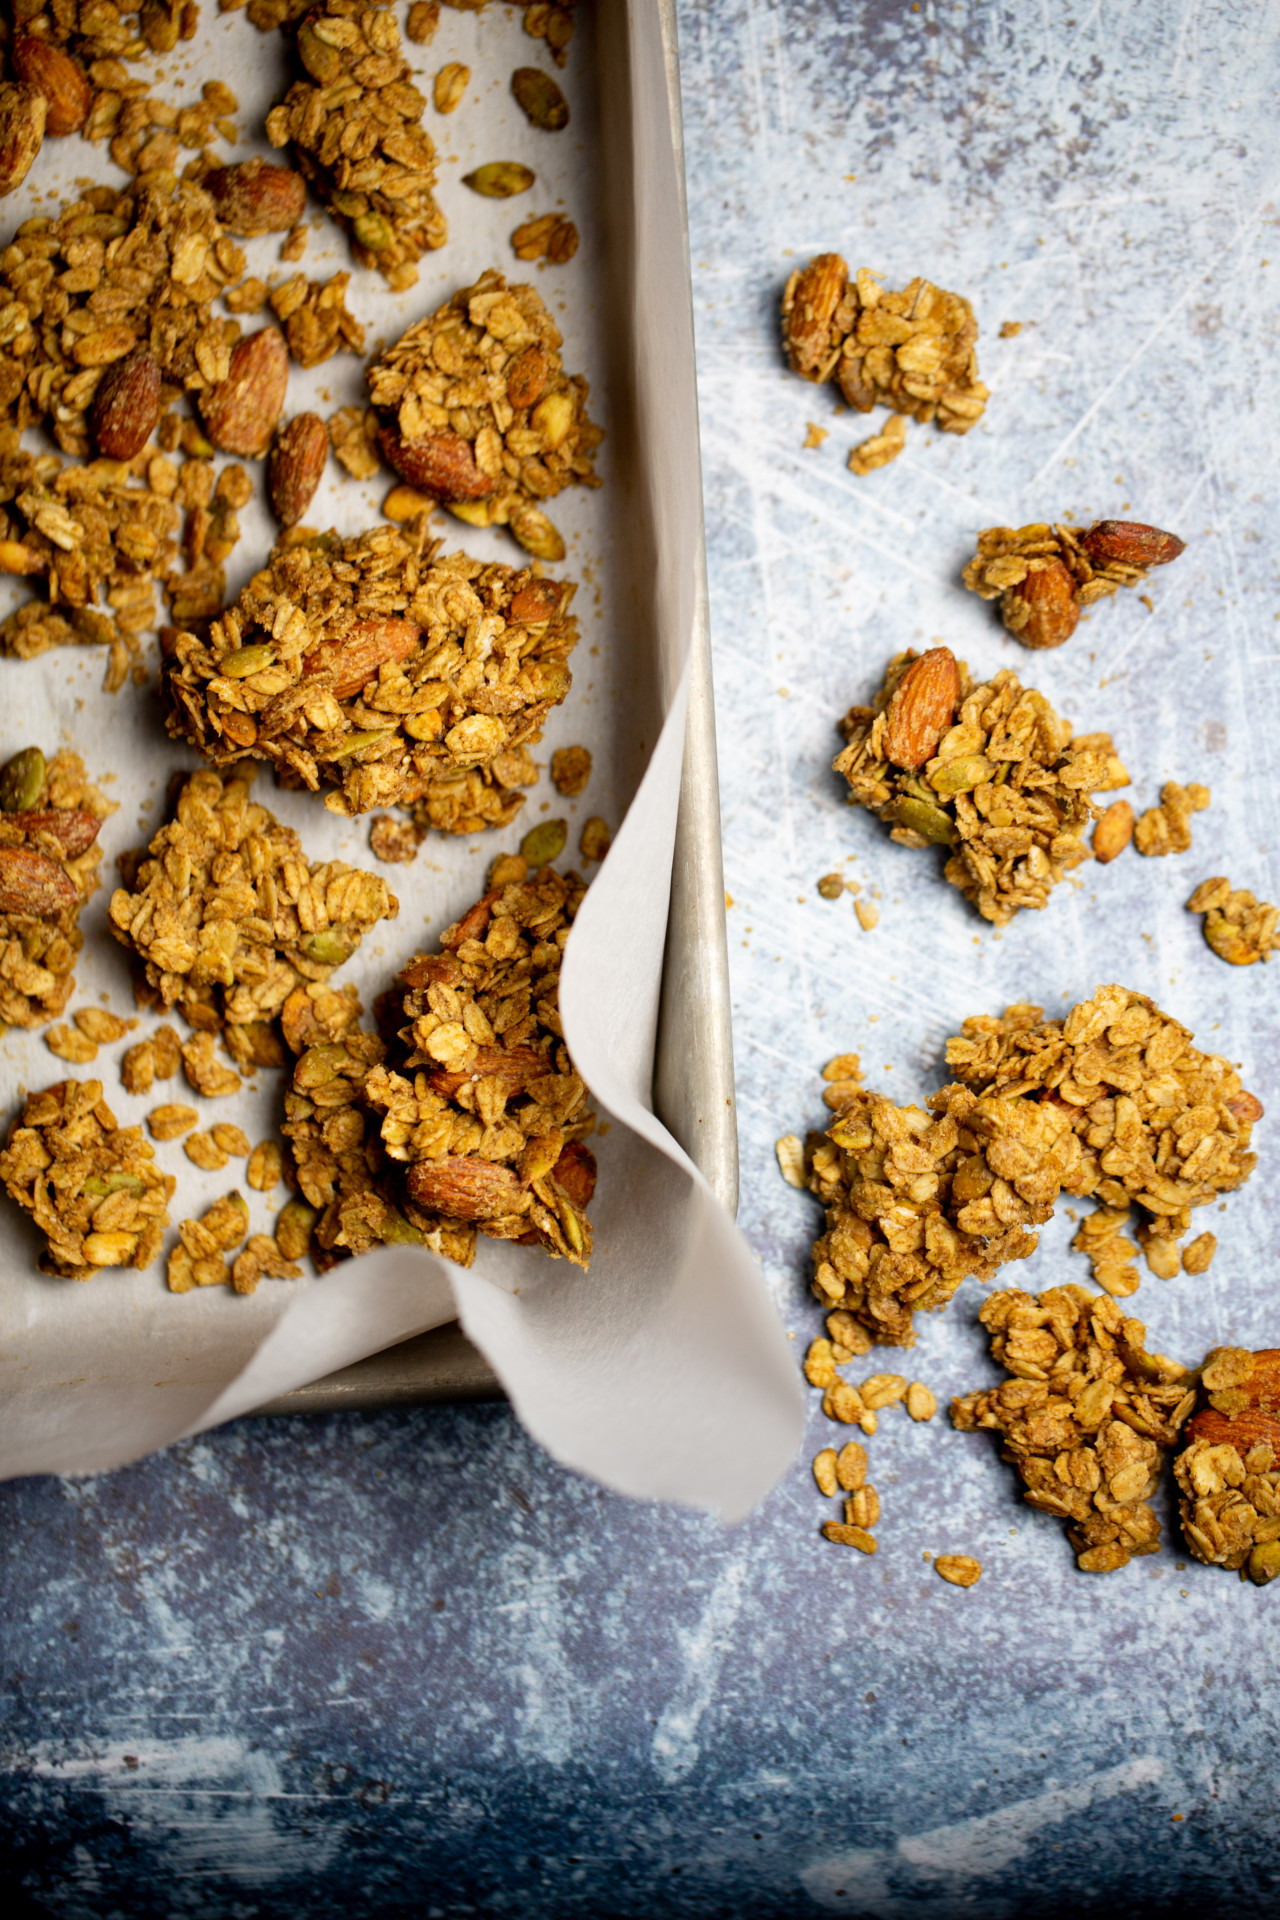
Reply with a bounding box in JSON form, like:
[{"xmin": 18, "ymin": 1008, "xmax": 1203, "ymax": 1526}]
[{"xmin": 0, "ymin": 1081, "xmax": 175, "ymax": 1281}]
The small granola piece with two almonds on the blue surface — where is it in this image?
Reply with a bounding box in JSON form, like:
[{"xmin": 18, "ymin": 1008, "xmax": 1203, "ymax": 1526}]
[{"xmin": 963, "ymin": 520, "xmax": 1184, "ymax": 649}]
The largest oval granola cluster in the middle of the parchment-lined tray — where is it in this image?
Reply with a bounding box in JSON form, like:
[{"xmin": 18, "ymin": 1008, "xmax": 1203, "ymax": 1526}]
[{"xmin": 165, "ymin": 520, "xmax": 578, "ymax": 833}]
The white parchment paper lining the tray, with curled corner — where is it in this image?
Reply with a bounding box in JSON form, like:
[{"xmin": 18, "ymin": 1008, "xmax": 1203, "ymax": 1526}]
[{"xmin": 0, "ymin": 0, "xmax": 802, "ymax": 1519}]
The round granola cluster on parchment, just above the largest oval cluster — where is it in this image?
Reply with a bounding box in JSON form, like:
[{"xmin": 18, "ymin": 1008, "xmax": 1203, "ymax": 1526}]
[{"xmin": 368, "ymin": 271, "xmax": 604, "ymax": 561}]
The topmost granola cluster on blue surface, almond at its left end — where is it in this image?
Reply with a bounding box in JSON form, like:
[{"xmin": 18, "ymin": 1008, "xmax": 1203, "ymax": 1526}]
[{"xmin": 783, "ymin": 253, "xmax": 988, "ymax": 437}]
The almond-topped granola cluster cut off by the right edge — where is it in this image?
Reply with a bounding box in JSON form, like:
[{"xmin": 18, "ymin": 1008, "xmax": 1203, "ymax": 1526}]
[{"xmin": 1173, "ymin": 1346, "xmax": 1280, "ymax": 1586}]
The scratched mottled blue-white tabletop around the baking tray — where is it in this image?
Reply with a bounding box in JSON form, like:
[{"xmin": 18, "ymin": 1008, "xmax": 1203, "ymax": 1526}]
[{"xmin": 0, "ymin": 0, "xmax": 1280, "ymax": 1920}]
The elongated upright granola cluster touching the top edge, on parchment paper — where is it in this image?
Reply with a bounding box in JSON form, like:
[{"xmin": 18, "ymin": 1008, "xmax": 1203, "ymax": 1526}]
[{"xmin": 267, "ymin": 0, "xmax": 447, "ymax": 292}]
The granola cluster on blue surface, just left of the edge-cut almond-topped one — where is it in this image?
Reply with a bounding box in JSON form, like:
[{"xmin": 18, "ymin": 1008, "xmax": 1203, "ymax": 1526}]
[{"xmin": 952, "ymin": 1286, "xmax": 1196, "ymax": 1572}]
